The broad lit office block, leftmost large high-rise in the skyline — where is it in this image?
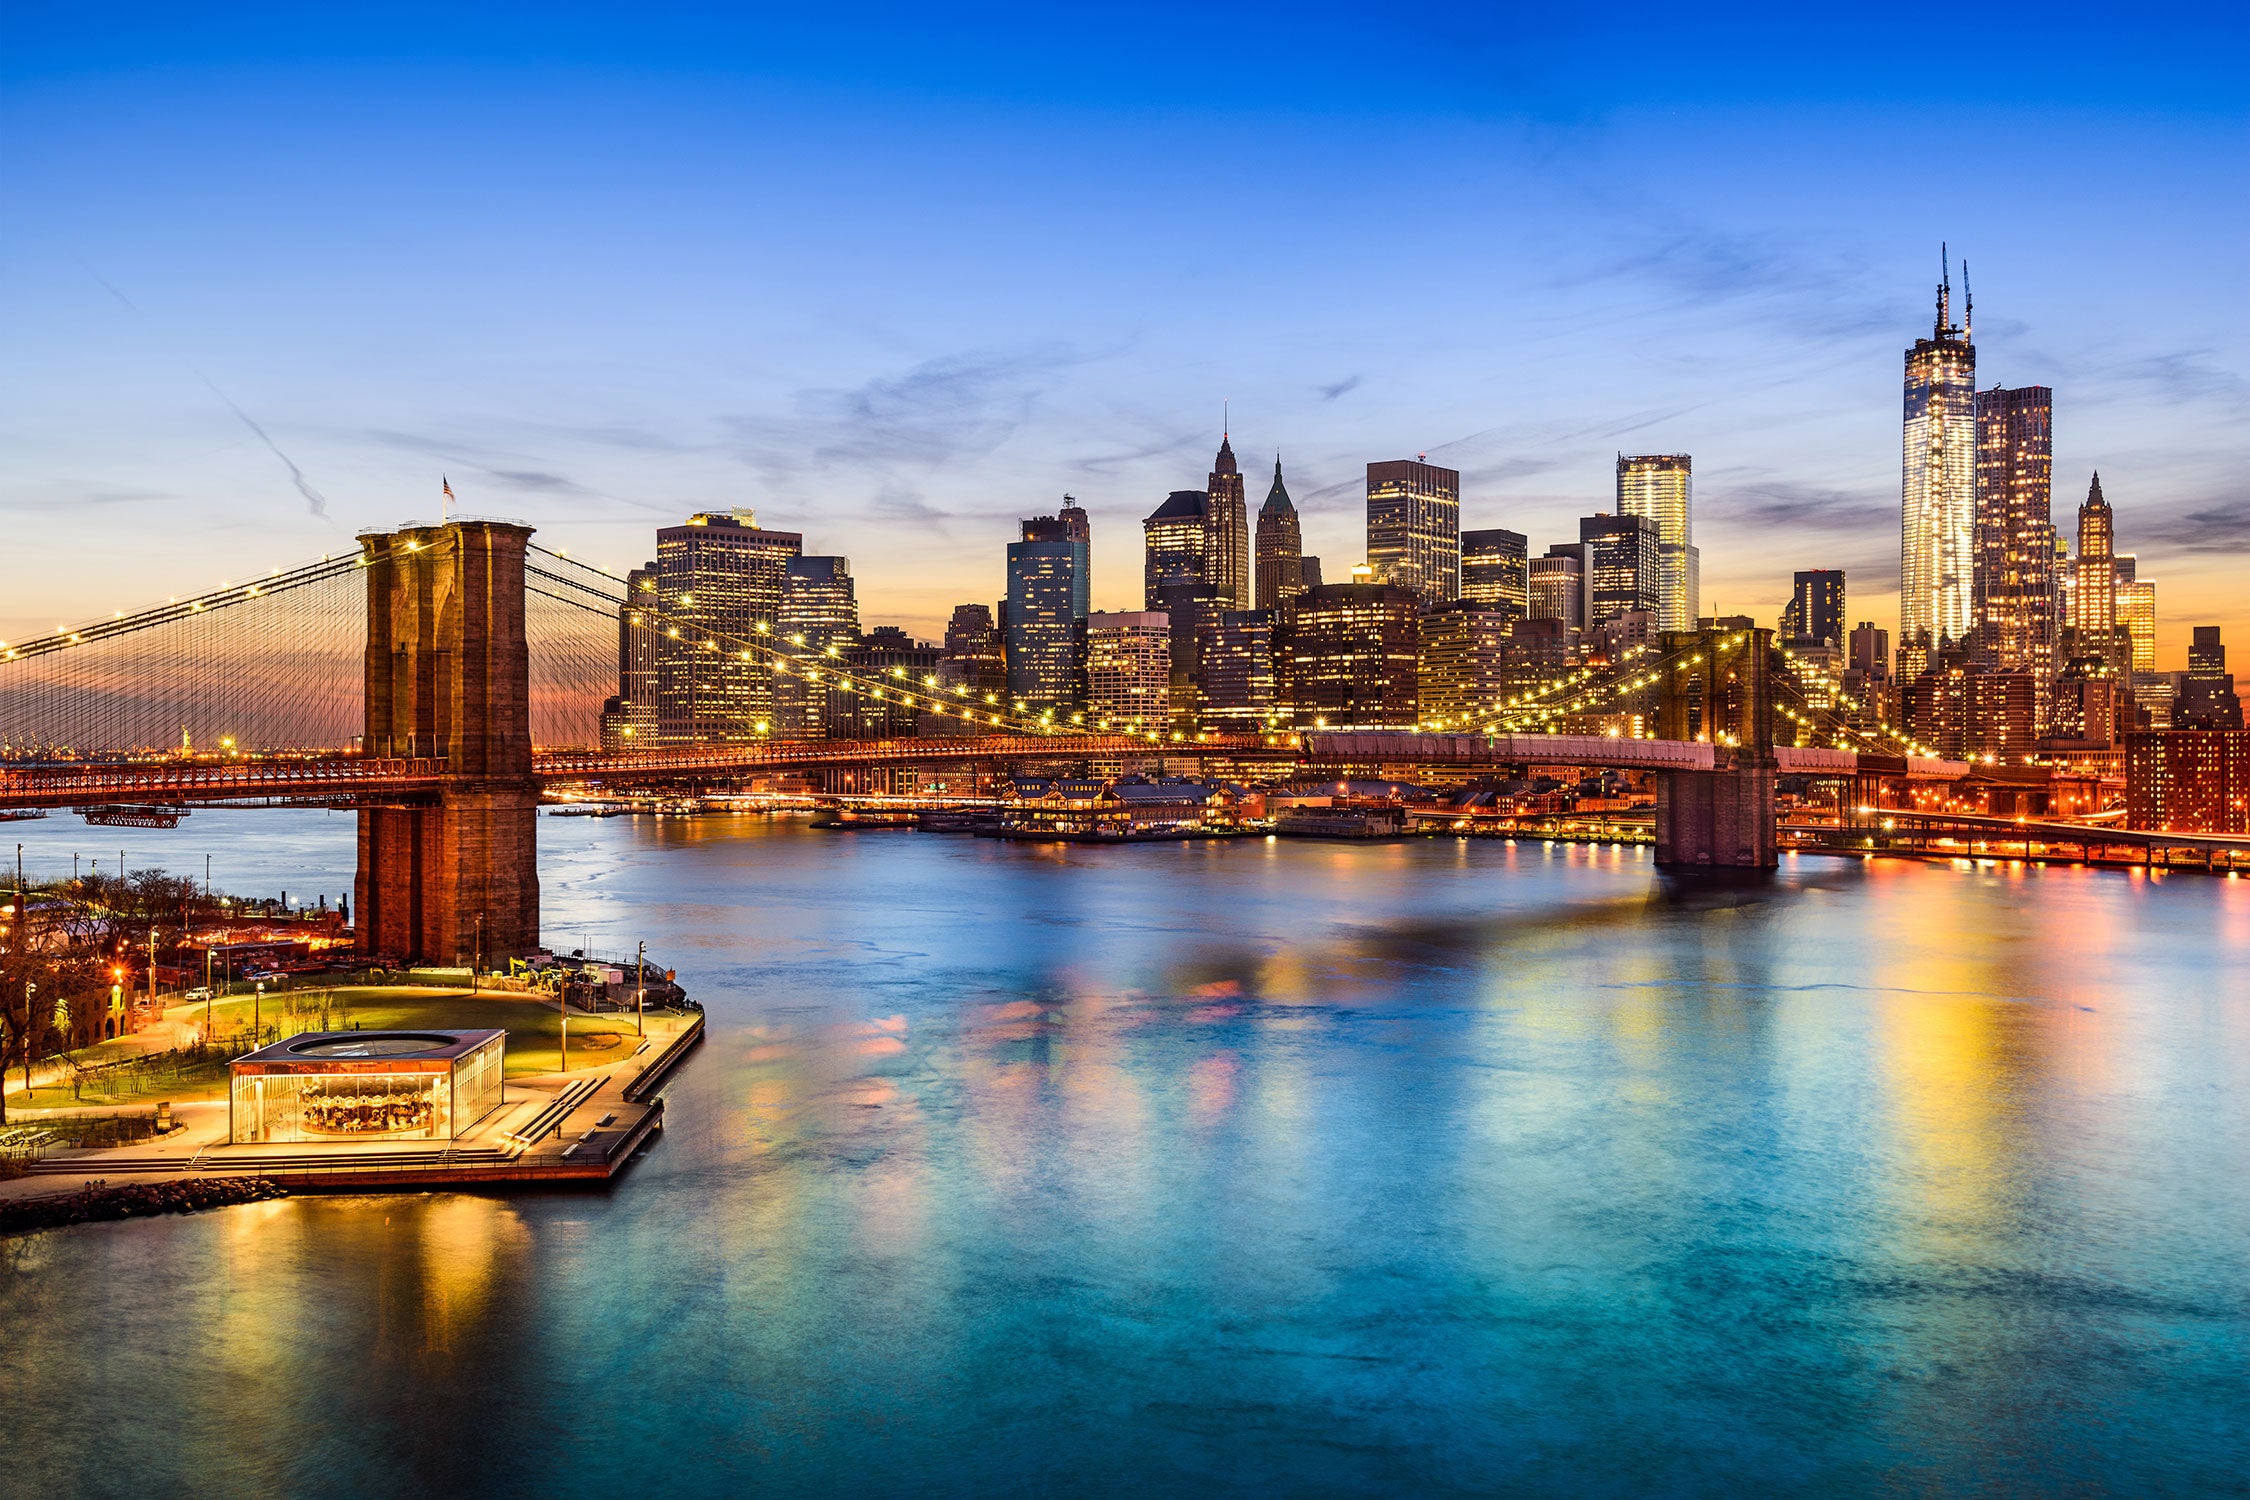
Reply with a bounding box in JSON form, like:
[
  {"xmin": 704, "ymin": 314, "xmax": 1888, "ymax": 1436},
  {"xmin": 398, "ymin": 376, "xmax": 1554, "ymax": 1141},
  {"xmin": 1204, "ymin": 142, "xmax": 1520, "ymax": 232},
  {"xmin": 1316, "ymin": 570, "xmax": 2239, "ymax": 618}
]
[{"xmin": 657, "ymin": 510, "xmax": 806, "ymax": 744}]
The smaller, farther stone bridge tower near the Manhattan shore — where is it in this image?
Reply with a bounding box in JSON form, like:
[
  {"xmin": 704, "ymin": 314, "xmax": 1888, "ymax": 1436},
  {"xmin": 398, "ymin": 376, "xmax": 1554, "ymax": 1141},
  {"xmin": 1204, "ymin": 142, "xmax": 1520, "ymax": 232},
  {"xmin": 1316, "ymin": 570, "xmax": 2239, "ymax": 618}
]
[{"xmin": 1656, "ymin": 630, "xmax": 1780, "ymax": 870}]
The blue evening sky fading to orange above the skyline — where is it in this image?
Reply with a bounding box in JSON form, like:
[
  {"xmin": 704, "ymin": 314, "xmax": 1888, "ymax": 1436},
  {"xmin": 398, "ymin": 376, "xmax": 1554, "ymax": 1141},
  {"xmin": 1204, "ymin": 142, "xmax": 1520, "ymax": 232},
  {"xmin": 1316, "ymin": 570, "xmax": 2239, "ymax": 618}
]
[{"xmin": 0, "ymin": 0, "xmax": 2250, "ymax": 668}]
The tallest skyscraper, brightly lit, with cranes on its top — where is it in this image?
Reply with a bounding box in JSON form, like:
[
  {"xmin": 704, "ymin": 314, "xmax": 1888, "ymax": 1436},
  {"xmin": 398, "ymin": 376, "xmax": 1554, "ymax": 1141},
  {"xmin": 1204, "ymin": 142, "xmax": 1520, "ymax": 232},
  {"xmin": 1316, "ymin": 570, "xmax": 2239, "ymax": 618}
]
[{"xmin": 1899, "ymin": 254, "xmax": 1976, "ymax": 648}]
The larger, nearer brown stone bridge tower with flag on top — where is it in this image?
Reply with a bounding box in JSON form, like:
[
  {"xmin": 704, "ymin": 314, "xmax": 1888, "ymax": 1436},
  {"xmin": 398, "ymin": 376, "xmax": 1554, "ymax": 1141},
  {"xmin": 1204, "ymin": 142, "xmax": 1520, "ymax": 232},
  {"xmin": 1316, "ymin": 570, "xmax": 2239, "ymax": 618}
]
[{"xmin": 358, "ymin": 522, "xmax": 540, "ymax": 965}]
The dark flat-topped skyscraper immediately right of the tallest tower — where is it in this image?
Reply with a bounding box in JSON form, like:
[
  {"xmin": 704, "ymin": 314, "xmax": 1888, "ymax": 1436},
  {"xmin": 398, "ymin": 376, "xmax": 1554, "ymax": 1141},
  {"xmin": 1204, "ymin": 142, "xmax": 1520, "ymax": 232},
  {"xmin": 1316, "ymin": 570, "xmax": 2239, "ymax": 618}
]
[{"xmin": 1971, "ymin": 385, "xmax": 2061, "ymax": 697}]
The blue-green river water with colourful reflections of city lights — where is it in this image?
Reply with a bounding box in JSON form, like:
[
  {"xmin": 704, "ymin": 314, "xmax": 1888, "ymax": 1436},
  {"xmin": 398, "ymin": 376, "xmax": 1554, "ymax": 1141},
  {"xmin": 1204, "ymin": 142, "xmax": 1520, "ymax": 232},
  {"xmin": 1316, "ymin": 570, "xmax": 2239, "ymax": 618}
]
[{"xmin": 0, "ymin": 812, "xmax": 2250, "ymax": 1498}]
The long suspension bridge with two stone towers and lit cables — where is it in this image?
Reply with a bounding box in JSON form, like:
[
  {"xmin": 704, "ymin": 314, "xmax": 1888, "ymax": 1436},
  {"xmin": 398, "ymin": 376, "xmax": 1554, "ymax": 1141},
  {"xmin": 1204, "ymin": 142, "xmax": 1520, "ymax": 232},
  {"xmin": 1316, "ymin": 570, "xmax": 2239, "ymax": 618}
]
[{"xmin": 0, "ymin": 519, "xmax": 1998, "ymax": 963}]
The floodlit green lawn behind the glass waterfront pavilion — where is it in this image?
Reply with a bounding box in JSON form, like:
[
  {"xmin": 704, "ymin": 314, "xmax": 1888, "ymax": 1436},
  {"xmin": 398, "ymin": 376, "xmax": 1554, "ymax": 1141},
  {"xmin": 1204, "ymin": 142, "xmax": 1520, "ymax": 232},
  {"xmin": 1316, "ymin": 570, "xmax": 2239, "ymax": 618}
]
[{"xmin": 9, "ymin": 985, "xmax": 657, "ymax": 1109}]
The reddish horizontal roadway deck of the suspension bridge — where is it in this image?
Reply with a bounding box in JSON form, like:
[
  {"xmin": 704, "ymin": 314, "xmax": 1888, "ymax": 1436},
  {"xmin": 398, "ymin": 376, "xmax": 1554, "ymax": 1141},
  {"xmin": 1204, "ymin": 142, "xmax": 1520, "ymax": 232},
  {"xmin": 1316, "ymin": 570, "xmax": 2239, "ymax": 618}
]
[{"xmin": 0, "ymin": 731, "xmax": 1969, "ymax": 807}]
